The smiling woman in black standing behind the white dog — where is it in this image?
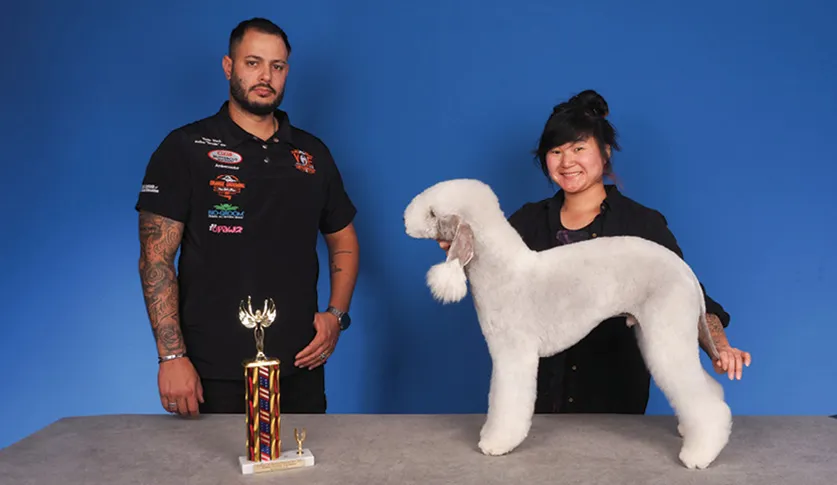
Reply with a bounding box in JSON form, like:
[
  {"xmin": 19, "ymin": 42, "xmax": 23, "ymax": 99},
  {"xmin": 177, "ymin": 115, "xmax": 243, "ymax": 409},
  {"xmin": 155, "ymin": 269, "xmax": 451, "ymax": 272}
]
[{"xmin": 440, "ymin": 90, "xmax": 751, "ymax": 414}]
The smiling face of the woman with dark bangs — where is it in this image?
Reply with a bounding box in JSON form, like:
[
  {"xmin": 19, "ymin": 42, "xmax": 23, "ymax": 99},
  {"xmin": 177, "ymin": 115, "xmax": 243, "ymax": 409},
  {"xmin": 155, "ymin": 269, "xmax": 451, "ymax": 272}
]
[{"xmin": 546, "ymin": 137, "xmax": 610, "ymax": 194}]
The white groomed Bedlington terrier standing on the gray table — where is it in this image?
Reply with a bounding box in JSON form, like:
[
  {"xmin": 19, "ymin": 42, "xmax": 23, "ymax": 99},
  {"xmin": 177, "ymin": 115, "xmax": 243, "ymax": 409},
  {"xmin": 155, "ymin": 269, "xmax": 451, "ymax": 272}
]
[{"xmin": 404, "ymin": 179, "xmax": 732, "ymax": 468}]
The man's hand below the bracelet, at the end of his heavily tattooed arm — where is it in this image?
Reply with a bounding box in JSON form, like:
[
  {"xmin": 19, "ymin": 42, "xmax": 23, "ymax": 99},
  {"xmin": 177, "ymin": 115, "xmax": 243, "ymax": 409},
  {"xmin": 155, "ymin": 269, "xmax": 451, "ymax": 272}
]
[{"xmin": 157, "ymin": 357, "xmax": 203, "ymax": 416}]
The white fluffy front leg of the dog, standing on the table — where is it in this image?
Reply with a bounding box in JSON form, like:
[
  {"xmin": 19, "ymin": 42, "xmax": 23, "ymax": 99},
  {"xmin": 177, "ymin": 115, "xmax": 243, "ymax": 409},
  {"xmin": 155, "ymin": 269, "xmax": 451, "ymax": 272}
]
[{"xmin": 479, "ymin": 346, "xmax": 538, "ymax": 455}]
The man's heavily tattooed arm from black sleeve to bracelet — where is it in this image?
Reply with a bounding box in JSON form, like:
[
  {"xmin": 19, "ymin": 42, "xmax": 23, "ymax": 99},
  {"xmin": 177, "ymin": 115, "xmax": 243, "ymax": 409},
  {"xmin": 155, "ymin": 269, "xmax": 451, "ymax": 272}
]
[{"xmin": 139, "ymin": 211, "xmax": 186, "ymax": 355}]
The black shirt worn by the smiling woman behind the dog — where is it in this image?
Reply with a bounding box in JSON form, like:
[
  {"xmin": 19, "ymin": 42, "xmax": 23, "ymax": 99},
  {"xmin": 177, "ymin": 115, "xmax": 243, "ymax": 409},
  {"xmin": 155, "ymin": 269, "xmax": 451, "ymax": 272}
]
[{"xmin": 509, "ymin": 185, "xmax": 730, "ymax": 414}]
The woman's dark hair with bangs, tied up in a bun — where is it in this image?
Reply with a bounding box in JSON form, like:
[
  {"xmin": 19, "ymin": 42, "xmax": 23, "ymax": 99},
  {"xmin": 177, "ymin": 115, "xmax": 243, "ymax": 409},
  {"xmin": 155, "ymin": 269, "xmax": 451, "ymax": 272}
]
[{"xmin": 535, "ymin": 89, "xmax": 619, "ymax": 180}]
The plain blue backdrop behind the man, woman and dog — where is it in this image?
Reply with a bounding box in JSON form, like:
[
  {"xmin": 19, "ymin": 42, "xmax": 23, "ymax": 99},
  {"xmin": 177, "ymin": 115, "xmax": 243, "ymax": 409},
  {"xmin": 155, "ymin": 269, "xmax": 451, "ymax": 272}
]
[{"xmin": 0, "ymin": 0, "xmax": 837, "ymax": 446}]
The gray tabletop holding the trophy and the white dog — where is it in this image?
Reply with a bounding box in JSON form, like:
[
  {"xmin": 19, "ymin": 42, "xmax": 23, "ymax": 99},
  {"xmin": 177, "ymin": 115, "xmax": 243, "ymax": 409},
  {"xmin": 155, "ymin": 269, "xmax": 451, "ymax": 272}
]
[{"xmin": 0, "ymin": 414, "xmax": 837, "ymax": 485}]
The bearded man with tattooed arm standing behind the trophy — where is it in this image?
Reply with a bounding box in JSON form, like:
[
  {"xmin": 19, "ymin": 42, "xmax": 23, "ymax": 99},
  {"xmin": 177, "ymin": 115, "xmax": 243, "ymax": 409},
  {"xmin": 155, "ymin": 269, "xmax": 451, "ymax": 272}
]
[{"xmin": 136, "ymin": 18, "xmax": 358, "ymax": 416}]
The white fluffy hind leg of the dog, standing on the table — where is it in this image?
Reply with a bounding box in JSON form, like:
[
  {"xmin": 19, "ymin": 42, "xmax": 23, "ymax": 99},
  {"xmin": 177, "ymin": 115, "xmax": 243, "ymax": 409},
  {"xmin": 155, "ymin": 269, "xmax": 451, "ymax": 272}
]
[{"xmin": 634, "ymin": 308, "xmax": 732, "ymax": 468}]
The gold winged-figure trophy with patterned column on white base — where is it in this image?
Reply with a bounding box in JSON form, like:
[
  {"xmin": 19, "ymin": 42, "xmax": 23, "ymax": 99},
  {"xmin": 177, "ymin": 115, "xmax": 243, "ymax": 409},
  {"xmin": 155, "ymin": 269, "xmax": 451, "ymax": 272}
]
[{"xmin": 238, "ymin": 296, "xmax": 314, "ymax": 475}]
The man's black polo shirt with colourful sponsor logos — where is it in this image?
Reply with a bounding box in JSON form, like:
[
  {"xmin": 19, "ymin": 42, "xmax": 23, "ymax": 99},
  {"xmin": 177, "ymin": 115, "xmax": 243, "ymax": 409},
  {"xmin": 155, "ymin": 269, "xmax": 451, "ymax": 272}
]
[{"xmin": 136, "ymin": 103, "xmax": 356, "ymax": 379}]
